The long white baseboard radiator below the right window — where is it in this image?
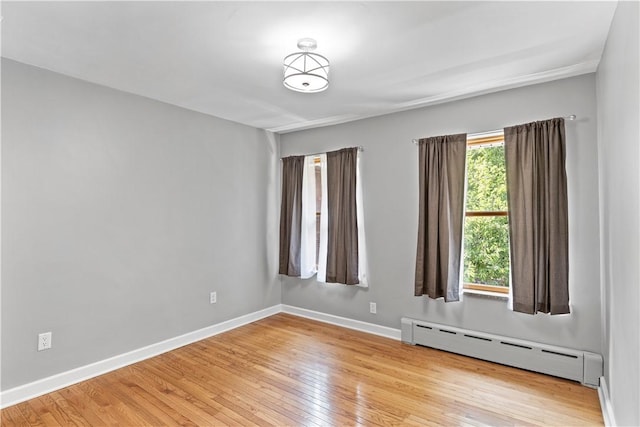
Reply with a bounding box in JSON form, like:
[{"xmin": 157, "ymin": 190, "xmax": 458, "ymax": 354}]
[{"xmin": 402, "ymin": 317, "xmax": 603, "ymax": 387}]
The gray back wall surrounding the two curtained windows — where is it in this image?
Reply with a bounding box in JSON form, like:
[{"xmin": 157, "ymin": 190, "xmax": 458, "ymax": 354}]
[{"xmin": 281, "ymin": 74, "xmax": 601, "ymax": 353}]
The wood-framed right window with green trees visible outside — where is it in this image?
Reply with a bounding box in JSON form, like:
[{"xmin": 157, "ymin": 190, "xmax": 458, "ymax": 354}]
[{"xmin": 463, "ymin": 133, "xmax": 509, "ymax": 294}]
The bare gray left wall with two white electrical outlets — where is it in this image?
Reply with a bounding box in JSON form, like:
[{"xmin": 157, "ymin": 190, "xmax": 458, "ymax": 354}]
[{"xmin": 1, "ymin": 59, "xmax": 281, "ymax": 390}]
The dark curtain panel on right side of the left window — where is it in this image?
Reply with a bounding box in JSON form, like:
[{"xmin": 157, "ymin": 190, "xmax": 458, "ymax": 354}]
[{"xmin": 326, "ymin": 148, "xmax": 359, "ymax": 285}]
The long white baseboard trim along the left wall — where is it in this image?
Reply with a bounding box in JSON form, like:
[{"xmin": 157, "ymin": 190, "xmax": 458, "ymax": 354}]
[{"xmin": 0, "ymin": 304, "xmax": 282, "ymax": 408}]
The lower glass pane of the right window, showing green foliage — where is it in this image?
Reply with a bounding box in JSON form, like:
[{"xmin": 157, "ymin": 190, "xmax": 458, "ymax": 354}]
[{"xmin": 463, "ymin": 216, "xmax": 509, "ymax": 287}]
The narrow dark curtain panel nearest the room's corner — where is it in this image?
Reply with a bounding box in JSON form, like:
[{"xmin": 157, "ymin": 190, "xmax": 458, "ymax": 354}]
[{"xmin": 278, "ymin": 156, "xmax": 304, "ymax": 277}]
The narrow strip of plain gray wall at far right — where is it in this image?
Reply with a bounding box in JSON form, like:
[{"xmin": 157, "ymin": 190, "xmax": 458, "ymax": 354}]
[{"xmin": 597, "ymin": 2, "xmax": 640, "ymax": 426}]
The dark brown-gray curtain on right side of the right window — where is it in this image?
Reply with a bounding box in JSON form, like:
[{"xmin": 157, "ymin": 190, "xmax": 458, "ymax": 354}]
[{"xmin": 504, "ymin": 118, "xmax": 569, "ymax": 314}]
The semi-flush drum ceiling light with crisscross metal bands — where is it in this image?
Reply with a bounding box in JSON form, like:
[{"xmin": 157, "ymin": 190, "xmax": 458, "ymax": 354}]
[{"xmin": 282, "ymin": 38, "xmax": 329, "ymax": 93}]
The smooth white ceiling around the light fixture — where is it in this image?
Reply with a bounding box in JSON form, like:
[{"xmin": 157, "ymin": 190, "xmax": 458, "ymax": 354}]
[{"xmin": 1, "ymin": 1, "xmax": 617, "ymax": 132}]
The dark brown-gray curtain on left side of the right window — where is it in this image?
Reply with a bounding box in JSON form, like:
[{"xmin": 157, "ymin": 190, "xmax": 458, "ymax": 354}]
[{"xmin": 415, "ymin": 134, "xmax": 467, "ymax": 302}]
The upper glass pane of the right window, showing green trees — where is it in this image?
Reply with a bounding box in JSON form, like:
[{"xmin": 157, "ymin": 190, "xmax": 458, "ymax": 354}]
[{"xmin": 466, "ymin": 144, "xmax": 507, "ymax": 211}]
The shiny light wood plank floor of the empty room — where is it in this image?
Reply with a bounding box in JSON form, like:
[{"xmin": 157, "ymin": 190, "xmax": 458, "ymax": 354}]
[{"xmin": 1, "ymin": 314, "xmax": 603, "ymax": 427}]
